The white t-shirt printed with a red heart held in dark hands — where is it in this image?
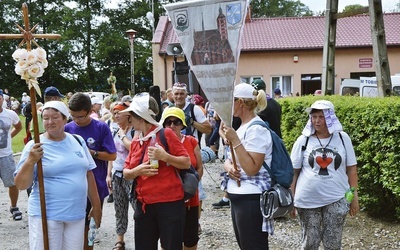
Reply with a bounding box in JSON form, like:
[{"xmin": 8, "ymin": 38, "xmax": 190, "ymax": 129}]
[{"xmin": 291, "ymin": 132, "xmax": 357, "ymax": 208}]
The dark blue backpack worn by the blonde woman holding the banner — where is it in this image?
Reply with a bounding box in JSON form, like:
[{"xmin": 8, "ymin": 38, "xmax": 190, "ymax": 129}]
[{"xmin": 245, "ymin": 121, "xmax": 293, "ymax": 188}]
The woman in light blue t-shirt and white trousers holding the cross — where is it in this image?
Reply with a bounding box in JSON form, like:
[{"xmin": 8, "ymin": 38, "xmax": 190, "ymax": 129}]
[{"xmin": 14, "ymin": 101, "xmax": 101, "ymax": 249}]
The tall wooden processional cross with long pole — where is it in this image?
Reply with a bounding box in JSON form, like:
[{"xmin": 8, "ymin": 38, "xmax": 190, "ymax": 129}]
[{"xmin": 0, "ymin": 3, "xmax": 61, "ymax": 250}]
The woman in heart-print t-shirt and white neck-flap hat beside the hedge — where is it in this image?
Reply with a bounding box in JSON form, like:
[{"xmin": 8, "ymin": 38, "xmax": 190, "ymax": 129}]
[{"xmin": 291, "ymin": 100, "xmax": 359, "ymax": 249}]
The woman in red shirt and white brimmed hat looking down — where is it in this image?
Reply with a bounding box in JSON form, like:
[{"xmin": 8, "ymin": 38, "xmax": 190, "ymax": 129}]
[{"xmin": 120, "ymin": 93, "xmax": 190, "ymax": 250}]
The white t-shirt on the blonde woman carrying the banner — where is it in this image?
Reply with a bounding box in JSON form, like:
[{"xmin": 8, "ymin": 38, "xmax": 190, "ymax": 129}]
[{"xmin": 227, "ymin": 116, "xmax": 272, "ymax": 194}]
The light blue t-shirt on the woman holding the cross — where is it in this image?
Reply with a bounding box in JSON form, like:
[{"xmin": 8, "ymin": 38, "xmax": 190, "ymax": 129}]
[{"xmin": 14, "ymin": 133, "xmax": 96, "ymax": 221}]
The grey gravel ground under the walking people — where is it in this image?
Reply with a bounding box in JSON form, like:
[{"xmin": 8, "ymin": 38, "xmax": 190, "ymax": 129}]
[{"xmin": 0, "ymin": 155, "xmax": 400, "ymax": 250}]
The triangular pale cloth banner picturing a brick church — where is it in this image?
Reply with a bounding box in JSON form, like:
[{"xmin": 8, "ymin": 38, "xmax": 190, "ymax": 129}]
[{"xmin": 164, "ymin": 0, "xmax": 248, "ymax": 125}]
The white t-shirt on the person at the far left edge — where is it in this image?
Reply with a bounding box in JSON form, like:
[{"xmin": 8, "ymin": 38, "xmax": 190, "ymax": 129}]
[{"xmin": 0, "ymin": 108, "xmax": 20, "ymax": 157}]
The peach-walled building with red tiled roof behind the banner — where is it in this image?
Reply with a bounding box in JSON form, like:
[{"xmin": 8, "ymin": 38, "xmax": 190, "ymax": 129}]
[{"xmin": 152, "ymin": 13, "xmax": 400, "ymax": 96}]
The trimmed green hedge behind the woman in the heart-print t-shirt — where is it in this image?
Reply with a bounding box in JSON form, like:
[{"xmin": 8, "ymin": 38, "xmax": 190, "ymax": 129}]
[{"xmin": 279, "ymin": 96, "xmax": 400, "ymax": 221}]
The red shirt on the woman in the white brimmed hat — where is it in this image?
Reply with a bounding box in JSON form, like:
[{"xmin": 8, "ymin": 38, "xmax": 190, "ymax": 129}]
[{"xmin": 124, "ymin": 126, "xmax": 188, "ymax": 205}]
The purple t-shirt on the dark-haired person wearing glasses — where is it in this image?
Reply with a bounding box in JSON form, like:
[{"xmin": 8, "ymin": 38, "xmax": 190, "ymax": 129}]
[{"xmin": 65, "ymin": 119, "xmax": 117, "ymax": 200}]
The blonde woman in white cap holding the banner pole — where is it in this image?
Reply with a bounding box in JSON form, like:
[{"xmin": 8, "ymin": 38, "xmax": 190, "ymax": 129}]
[{"xmin": 222, "ymin": 83, "xmax": 273, "ymax": 250}]
